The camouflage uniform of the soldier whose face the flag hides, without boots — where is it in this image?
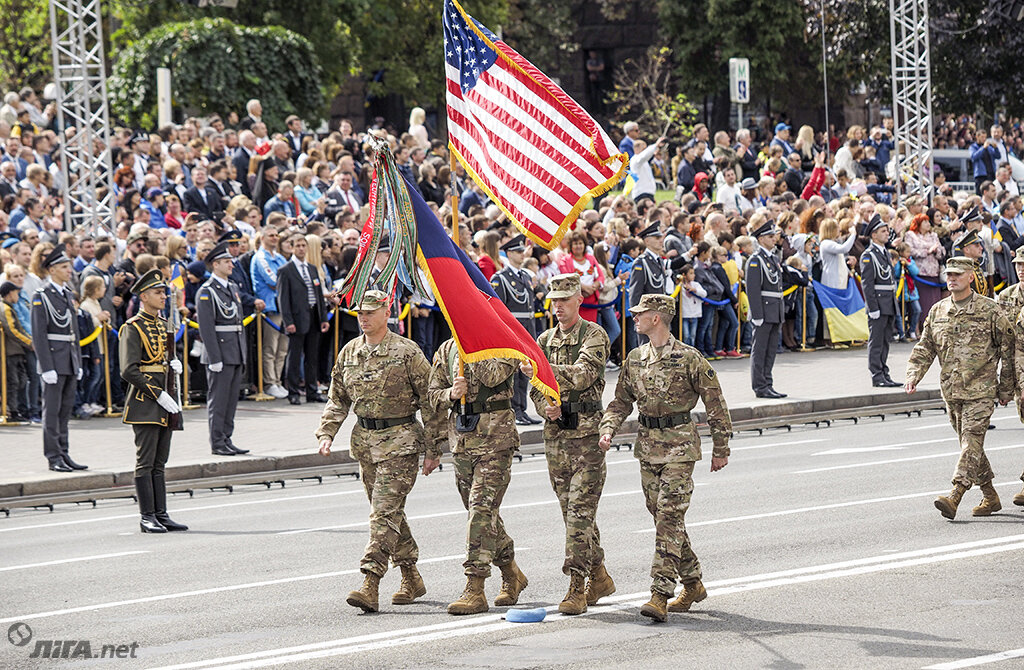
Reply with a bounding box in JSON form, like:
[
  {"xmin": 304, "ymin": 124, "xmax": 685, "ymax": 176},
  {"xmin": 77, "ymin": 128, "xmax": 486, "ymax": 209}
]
[{"xmin": 429, "ymin": 339, "xmax": 519, "ymax": 578}]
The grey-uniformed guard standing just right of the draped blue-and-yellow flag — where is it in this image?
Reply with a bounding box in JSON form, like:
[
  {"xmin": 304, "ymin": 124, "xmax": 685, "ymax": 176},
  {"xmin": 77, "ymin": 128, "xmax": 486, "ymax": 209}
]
[{"xmin": 860, "ymin": 214, "xmax": 902, "ymax": 388}]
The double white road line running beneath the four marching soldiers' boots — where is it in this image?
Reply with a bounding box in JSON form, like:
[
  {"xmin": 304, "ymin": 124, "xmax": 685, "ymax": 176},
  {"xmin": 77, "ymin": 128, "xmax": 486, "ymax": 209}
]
[{"xmin": 142, "ymin": 535, "xmax": 1024, "ymax": 670}]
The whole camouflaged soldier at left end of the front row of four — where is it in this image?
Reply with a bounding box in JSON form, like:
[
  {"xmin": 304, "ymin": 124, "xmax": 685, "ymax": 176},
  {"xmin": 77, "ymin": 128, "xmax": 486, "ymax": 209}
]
[{"xmin": 316, "ymin": 291, "xmax": 444, "ymax": 612}]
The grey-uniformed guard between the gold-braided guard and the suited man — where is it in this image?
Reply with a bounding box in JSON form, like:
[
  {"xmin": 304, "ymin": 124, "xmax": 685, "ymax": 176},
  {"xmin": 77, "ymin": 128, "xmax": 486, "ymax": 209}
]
[{"xmin": 196, "ymin": 242, "xmax": 249, "ymax": 456}]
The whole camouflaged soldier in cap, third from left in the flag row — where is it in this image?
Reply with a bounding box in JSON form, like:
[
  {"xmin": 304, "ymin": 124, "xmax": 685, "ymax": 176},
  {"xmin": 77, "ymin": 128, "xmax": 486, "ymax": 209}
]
[{"xmin": 520, "ymin": 273, "xmax": 615, "ymax": 615}]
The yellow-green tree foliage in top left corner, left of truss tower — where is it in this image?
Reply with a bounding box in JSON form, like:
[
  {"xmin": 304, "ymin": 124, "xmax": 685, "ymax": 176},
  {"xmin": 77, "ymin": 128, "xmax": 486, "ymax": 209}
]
[{"xmin": 0, "ymin": 0, "xmax": 53, "ymax": 91}]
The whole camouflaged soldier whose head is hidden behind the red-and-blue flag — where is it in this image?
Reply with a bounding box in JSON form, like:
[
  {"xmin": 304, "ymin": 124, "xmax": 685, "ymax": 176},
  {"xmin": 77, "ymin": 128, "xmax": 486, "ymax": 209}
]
[{"xmin": 430, "ymin": 339, "xmax": 527, "ymax": 615}]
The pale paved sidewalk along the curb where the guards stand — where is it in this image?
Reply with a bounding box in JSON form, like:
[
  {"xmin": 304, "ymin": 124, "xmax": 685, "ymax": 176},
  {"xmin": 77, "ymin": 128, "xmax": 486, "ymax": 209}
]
[{"xmin": 0, "ymin": 344, "xmax": 938, "ymax": 498}]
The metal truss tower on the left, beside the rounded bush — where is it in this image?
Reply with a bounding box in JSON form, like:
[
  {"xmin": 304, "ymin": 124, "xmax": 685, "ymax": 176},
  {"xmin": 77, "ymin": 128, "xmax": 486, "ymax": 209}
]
[{"xmin": 50, "ymin": 0, "xmax": 114, "ymax": 231}]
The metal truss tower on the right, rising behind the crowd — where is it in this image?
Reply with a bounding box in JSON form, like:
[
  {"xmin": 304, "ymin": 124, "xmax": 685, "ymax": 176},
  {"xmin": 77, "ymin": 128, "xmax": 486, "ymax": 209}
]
[{"xmin": 889, "ymin": 0, "xmax": 932, "ymax": 197}]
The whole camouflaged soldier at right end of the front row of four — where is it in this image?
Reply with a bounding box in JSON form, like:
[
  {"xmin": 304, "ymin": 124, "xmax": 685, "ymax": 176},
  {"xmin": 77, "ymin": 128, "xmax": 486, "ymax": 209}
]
[{"xmin": 600, "ymin": 294, "xmax": 732, "ymax": 622}]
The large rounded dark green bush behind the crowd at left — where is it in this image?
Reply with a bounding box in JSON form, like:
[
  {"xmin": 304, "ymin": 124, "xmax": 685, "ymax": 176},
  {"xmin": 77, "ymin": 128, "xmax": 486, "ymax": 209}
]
[{"xmin": 106, "ymin": 18, "xmax": 325, "ymax": 128}]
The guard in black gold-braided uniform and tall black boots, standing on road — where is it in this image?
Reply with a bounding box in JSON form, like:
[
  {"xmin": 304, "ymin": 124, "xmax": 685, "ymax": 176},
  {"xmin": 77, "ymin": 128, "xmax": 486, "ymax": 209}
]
[{"xmin": 118, "ymin": 268, "xmax": 188, "ymax": 533}]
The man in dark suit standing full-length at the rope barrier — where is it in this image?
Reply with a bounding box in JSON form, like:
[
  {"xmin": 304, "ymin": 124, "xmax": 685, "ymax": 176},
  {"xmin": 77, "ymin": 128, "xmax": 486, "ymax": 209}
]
[{"xmin": 278, "ymin": 233, "xmax": 331, "ymax": 405}]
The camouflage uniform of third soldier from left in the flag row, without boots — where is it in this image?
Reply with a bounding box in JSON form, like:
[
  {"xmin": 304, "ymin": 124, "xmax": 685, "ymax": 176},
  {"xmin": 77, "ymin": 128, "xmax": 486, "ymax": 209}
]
[{"xmin": 530, "ymin": 319, "xmax": 611, "ymax": 575}]
